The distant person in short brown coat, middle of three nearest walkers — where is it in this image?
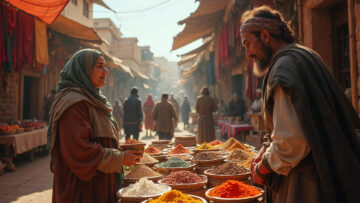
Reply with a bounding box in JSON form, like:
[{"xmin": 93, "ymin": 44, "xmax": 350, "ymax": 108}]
[{"xmin": 152, "ymin": 94, "xmax": 177, "ymax": 140}]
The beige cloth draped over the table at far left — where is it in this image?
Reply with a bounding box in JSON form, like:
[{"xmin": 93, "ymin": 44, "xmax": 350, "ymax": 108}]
[{"xmin": 0, "ymin": 127, "xmax": 48, "ymax": 156}]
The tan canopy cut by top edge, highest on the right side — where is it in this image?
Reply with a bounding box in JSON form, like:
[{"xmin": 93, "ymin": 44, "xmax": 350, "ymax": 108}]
[{"xmin": 172, "ymin": 0, "xmax": 229, "ymax": 50}]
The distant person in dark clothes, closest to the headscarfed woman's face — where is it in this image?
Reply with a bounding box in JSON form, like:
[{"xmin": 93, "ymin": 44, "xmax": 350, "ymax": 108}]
[{"xmin": 124, "ymin": 87, "xmax": 143, "ymax": 140}]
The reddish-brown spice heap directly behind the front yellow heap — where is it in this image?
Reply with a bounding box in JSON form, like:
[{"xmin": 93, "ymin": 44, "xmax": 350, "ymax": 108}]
[{"xmin": 162, "ymin": 171, "xmax": 204, "ymax": 184}]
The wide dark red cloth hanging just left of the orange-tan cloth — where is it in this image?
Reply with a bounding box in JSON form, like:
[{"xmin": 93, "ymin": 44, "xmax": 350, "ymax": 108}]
[{"xmin": 14, "ymin": 11, "xmax": 34, "ymax": 71}]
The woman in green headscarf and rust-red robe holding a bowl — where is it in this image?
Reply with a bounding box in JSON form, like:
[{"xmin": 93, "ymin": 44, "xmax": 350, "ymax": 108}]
[{"xmin": 48, "ymin": 49, "xmax": 141, "ymax": 203}]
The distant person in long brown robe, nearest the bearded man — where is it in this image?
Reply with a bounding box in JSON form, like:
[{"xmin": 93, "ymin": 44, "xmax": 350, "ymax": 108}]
[{"xmin": 195, "ymin": 87, "xmax": 218, "ymax": 144}]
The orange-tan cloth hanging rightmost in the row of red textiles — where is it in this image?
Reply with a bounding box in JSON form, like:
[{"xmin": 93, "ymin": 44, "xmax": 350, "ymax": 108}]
[{"xmin": 35, "ymin": 19, "xmax": 49, "ymax": 65}]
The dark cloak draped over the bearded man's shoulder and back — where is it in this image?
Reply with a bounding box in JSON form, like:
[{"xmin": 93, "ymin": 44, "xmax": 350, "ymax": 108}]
[{"xmin": 263, "ymin": 45, "xmax": 360, "ymax": 202}]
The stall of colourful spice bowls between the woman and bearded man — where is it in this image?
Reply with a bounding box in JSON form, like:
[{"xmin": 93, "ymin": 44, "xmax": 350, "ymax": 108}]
[{"xmin": 117, "ymin": 137, "xmax": 264, "ymax": 203}]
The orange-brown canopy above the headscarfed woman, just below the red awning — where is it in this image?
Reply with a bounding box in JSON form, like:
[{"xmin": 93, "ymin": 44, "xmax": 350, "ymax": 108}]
[{"xmin": 48, "ymin": 15, "xmax": 103, "ymax": 44}]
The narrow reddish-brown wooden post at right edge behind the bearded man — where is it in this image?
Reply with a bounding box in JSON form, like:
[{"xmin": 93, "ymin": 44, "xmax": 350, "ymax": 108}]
[{"xmin": 347, "ymin": 0, "xmax": 359, "ymax": 112}]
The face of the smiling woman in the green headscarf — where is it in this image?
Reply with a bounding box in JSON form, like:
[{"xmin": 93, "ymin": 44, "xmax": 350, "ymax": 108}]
[{"xmin": 91, "ymin": 56, "xmax": 109, "ymax": 88}]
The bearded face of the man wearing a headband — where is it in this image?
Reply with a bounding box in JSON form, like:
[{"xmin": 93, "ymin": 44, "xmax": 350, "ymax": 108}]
[{"xmin": 241, "ymin": 32, "xmax": 273, "ymax": 76}]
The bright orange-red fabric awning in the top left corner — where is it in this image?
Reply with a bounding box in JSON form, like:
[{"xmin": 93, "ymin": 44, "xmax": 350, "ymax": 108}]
[{"xmin": 5, "ymin": 0, "xmax": 69, "ymax": 24}]
